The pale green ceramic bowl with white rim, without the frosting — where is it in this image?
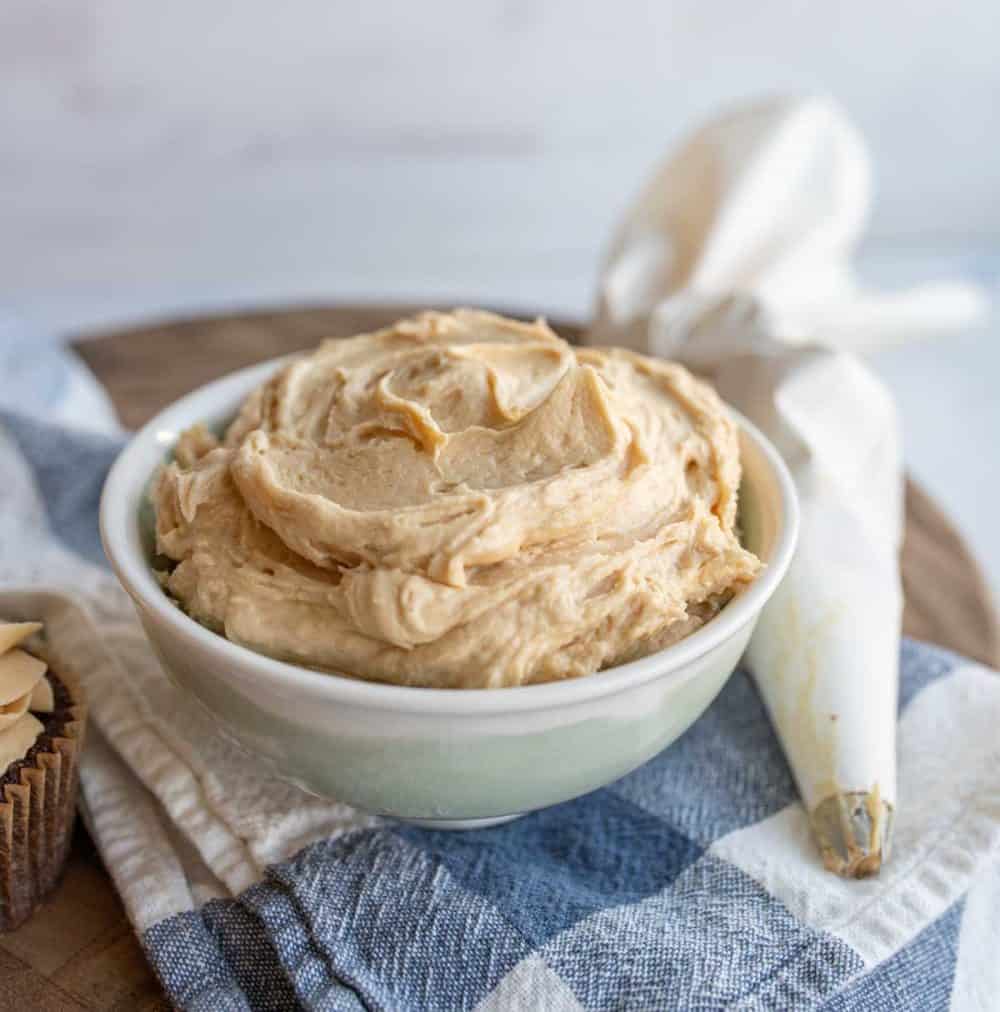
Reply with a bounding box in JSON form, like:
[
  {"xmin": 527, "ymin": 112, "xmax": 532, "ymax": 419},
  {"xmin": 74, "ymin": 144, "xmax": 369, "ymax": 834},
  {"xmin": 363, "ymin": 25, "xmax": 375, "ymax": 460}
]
[{"xmin": 100, "ymin": 359, "xmax": 799, "ymax": 828}]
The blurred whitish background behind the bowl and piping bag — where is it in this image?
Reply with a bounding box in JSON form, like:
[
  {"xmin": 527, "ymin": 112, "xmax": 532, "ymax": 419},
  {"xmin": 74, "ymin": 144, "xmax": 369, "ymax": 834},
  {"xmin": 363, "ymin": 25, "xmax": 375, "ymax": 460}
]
[{"xmin": 0, "ymin": 0, "xmax": 1000, "ymax": 595}]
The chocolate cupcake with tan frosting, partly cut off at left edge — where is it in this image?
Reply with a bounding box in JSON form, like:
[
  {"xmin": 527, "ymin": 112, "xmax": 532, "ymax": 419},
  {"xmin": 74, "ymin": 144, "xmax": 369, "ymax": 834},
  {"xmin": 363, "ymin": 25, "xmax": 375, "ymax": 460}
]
[{"xmin": 0, "ymin": 621, "xmax": 86, "ymax": 932}]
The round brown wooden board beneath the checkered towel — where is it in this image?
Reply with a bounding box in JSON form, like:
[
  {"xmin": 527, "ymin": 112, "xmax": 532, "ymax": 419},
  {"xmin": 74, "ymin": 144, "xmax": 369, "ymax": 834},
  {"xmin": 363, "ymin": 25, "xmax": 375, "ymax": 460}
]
[{"xmin": 0, "ymin": 306, "xmax": 1000, "ymax": 1012}]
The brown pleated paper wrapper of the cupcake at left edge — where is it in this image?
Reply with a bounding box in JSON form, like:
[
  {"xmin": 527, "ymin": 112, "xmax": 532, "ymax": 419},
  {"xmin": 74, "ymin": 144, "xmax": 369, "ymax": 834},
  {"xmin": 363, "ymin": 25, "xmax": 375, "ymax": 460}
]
[{"xmin": 0, "ymin": 665, "xmax": 87, "ymax": 933}]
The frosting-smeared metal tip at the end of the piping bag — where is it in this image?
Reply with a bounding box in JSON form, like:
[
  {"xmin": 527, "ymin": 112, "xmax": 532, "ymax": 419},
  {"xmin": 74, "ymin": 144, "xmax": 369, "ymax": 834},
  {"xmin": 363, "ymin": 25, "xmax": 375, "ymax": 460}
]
[{"xmin": 809, "ymin": 786, "xmax": 894, "ymax": 878}]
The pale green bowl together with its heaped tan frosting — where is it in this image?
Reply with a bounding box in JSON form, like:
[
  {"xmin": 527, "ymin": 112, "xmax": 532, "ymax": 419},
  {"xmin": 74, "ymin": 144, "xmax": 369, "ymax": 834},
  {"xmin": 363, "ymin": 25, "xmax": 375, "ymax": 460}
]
[{"xmin": 101, "ymin": 310, "xmax": 798, "ymax": 828}]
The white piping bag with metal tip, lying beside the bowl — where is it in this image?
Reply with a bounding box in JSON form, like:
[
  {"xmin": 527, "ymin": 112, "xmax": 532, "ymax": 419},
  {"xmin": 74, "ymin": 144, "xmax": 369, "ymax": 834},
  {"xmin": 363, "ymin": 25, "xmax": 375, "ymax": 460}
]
[{"xmin": 586, "ymin": 98, "xmax": 987, "ymax": 877}]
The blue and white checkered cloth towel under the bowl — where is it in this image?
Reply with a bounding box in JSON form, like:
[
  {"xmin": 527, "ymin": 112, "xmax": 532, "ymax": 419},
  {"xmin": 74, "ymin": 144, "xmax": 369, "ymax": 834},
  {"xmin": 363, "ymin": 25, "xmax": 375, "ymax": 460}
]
[{"xmin": 0, "ymin": 333, "xmax": 1000, "ymax": 1012}]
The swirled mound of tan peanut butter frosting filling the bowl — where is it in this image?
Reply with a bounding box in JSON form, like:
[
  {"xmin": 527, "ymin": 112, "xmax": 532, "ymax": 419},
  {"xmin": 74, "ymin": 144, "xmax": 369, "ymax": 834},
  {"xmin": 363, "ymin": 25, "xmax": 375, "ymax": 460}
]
[{"xmin": 153, "ymin": 310, "xmax": 760, "ymax": 688}]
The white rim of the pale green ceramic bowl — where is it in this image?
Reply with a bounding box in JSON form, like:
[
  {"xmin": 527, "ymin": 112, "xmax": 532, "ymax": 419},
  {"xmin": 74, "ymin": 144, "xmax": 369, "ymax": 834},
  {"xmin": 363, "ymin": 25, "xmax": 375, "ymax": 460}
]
[{"xmin": 100, "ymin": 355, "xmax": 799, "ymax": 716}]
